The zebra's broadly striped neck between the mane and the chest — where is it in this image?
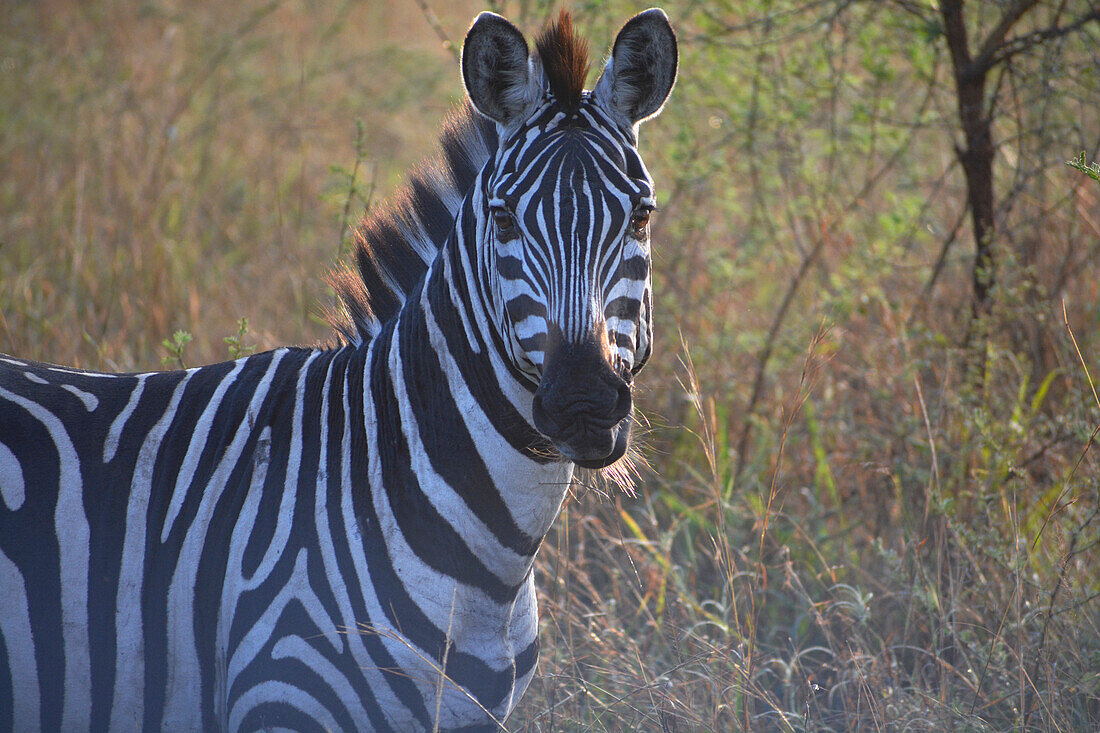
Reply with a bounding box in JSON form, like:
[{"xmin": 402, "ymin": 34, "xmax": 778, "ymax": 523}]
[{"xmin": 366, "ymin": 250, "xmax": 572, "ymax": 576}]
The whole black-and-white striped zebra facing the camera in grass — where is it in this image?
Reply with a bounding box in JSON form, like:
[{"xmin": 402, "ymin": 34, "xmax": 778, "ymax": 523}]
[{"xmin": 0, "ymin": 9, "xmax": 678, "ymax": 731}]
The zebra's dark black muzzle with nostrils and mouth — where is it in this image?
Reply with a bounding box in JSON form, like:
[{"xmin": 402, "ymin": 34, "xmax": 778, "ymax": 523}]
[{"xmin": 531, "ymin": 340, "xmax": 633, "ymax": 468}]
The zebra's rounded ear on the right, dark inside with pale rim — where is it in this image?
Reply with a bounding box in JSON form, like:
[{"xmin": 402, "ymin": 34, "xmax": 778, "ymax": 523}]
[{"xmin": 593, "ymin": 8, "xmax": 679, "ymax": 125}]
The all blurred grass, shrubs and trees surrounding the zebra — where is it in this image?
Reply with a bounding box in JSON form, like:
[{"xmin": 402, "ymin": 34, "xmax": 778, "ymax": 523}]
[{"xmin": 0, "ymin": 0, "xmax": 1100, "ymax": 731}]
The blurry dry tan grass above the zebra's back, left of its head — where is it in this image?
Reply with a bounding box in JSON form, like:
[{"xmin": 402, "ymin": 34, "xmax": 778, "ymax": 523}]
[{"xmin": 0, "ymin": 2, "xmax": 472, "ymax": 369}]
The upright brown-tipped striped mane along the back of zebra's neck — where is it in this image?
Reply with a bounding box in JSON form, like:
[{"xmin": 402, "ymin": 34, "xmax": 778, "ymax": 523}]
[{"xmin": 326, "ymin": 102, "xmax": 496, "ymax": 344}]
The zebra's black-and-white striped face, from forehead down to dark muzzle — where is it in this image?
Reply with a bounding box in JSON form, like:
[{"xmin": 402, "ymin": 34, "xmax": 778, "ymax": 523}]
[{"xmin": 485, "ymin": 107, "xmax": 653, "ymax": 374}]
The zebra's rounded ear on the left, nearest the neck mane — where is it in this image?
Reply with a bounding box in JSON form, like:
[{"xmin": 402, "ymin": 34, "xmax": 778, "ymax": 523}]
[{"xmin": 462, "ymin": 11, "xmax": 542, "ymax": 127}]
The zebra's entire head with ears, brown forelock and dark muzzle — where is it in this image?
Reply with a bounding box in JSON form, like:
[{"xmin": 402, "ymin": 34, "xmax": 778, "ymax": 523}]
[{"xmin": 462, "ymin": 9, "xmax": 678, "ymax": 468}]
